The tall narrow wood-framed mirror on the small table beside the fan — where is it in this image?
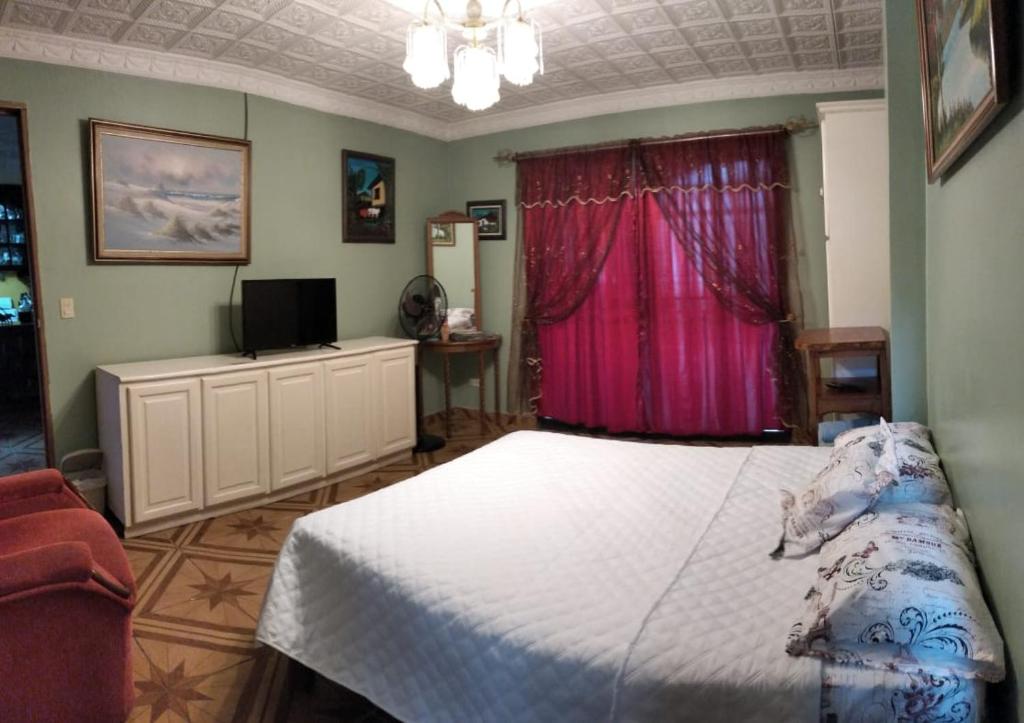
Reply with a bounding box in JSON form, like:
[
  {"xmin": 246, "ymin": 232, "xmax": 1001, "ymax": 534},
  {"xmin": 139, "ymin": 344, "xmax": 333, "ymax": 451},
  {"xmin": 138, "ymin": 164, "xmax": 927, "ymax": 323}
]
[{"xmin": 427, "ymin": 211, "xmax": 483, "ymax": 329}]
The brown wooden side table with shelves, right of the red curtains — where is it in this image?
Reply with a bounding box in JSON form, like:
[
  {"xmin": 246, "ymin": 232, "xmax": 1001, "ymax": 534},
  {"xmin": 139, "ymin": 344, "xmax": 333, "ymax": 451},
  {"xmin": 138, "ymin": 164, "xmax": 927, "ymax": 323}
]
[{"xmin": 796, "ymin": 327, "xmax": 892, "ymax": 440}]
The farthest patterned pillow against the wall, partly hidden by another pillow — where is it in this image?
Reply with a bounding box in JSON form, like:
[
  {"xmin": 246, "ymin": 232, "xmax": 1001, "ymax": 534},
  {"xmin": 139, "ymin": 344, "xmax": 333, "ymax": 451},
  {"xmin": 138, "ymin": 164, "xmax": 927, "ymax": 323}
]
[{"xmin": 868, "ymin": 422, "xmax": 952, "ymax": 506}]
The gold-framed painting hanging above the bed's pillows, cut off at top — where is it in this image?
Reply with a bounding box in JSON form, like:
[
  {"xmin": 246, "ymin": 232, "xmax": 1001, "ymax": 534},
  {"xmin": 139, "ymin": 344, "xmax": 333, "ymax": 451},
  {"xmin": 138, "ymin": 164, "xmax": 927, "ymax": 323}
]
[{"xmin": 916, "ymin": 0, "xmax": 1010, "ymax": 183}]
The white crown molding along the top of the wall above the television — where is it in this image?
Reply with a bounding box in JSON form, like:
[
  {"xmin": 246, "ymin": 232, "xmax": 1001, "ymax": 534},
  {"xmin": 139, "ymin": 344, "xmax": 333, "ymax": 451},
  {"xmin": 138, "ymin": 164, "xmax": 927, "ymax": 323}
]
[{"xmin": 0, "ymin": 28, "xmax": 446, "ymax": 140}]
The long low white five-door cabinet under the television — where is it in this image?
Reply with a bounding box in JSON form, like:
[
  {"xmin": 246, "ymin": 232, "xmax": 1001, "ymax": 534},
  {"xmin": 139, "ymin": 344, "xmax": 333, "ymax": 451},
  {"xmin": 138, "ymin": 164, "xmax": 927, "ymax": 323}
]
[{"xmin": 96, "ymin": 337, "xmax": 416, "ymax": 537}]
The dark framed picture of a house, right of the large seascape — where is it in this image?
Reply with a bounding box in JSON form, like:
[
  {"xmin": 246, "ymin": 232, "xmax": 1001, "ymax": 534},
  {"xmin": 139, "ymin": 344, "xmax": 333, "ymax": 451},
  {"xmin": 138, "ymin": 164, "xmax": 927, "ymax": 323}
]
[{"xmin": 341, "ymin": 151, "xmax": 395, "ymax": 244}]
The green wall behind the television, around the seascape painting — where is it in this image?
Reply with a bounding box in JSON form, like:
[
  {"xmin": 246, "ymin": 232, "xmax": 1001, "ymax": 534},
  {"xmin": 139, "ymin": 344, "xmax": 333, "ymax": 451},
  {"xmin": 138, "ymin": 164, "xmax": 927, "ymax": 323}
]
[{"xmin": 0, "ymin": 59, "xmax": 447, "ymax": 456}]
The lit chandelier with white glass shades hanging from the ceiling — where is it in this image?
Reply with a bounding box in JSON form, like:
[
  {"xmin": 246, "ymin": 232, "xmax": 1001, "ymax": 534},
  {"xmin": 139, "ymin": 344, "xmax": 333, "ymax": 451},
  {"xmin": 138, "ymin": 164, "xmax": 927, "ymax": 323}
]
[{"xmin": 402, "ymin": 0, "xmax": 544, "ymax": 111}]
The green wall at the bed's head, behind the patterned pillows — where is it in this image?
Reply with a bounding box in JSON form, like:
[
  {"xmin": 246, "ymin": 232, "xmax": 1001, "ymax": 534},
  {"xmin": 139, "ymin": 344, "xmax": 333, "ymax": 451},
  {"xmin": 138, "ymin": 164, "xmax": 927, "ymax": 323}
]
[{"xmin": 926, "ymin": 29, "xmax": 1024, "ymax": 721}]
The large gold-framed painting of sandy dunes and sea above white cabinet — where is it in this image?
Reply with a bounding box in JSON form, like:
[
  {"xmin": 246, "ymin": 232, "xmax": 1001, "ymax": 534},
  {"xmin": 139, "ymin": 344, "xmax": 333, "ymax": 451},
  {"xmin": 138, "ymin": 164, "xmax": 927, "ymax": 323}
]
[{"xmin": 89, "ymin": 119, "xmax": 251, "ymax": 264}]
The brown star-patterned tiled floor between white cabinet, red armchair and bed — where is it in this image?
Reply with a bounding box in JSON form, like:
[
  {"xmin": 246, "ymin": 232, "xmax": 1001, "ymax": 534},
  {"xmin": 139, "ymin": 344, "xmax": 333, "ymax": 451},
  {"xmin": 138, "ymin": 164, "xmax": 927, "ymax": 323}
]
[{"xmin": 124, "ymin": 410, "xmax": 536, "ymax": 723}]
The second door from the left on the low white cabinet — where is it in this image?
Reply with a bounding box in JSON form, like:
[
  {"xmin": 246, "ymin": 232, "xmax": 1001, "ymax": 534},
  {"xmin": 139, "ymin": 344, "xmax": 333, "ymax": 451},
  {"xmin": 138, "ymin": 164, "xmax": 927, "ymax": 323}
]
[{"xmin": 203, "ymin": 372, "xmax": 270, "ymax": 506}]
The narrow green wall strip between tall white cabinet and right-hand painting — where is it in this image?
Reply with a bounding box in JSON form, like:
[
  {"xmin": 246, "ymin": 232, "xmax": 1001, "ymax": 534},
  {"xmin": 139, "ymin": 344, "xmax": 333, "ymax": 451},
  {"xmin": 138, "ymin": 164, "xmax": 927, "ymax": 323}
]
[{"xmin": 886, "ymin": 0, "xmax": 928, "ymax": 422}]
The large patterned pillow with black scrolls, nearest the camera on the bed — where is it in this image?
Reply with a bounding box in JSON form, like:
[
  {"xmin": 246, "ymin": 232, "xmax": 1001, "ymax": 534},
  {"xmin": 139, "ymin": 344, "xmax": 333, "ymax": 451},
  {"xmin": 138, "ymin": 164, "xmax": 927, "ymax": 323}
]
[{"xmin": 786, "ymin": 504, "xmax": 1006, "ymax": 682}]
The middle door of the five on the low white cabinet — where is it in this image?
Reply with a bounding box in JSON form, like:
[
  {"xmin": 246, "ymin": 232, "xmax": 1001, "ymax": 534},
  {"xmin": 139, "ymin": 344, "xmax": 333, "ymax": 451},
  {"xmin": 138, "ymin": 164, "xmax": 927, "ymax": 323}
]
[{"xmin": 268, "ymin": 364, "xmax": 326, "ymax": 490}]
